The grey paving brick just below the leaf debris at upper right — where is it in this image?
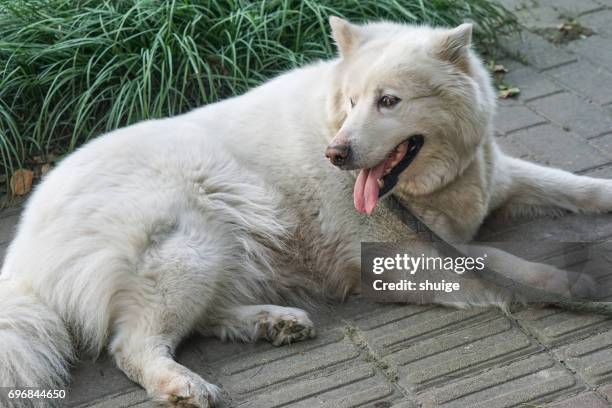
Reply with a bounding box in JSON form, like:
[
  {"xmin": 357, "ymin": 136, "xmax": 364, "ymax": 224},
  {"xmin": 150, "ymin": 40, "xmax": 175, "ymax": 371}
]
[{"xmin": 503, "ymin": 31, "xmax": 576, "ymax": 69}]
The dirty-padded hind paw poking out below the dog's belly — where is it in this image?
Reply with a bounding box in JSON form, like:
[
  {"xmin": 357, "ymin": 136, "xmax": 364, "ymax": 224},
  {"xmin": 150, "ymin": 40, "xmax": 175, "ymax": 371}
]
[{"xmin": 261, "ymin": 307, "xmax": 316, "ymax": 346}]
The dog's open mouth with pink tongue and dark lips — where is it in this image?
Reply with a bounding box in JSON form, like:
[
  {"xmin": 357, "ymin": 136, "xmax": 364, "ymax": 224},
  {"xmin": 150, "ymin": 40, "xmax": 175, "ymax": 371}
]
[{"xmin": 353, "ymin": 135, "xmax": 424, "ymax": 214}]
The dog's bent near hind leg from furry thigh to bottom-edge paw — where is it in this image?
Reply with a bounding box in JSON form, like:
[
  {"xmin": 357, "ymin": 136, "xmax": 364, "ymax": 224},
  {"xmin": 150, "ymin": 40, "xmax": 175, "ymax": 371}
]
[{"xmin": 109, "ymin": 225, "xmax": 236, "ymax": 407}]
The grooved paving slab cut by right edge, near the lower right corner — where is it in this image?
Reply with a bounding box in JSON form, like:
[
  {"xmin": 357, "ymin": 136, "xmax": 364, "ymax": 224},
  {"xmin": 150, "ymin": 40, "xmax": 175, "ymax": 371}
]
[{"xmin": 555, "ymin": 330, "xmax": 612, "ymax": 385}]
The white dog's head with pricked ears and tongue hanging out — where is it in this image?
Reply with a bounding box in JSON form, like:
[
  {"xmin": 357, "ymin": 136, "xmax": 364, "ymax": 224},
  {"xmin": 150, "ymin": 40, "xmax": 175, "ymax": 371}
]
[{"xmin": 326, "ymin": 17, "xmax": 494, "ymax": 213}]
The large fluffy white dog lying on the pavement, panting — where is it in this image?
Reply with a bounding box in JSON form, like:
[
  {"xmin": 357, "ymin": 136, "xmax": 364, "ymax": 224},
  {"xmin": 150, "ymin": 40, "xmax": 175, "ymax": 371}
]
[{"xmin": 0, "ymin": 18, "xmax": 612, "ymax": 407}]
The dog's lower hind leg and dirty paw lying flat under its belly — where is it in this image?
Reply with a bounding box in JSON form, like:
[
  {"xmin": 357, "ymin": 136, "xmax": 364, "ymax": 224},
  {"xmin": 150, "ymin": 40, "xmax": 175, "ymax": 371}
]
[{"xmin": 205, "ymin": 305, "xmax": 316, "ymax": 346}]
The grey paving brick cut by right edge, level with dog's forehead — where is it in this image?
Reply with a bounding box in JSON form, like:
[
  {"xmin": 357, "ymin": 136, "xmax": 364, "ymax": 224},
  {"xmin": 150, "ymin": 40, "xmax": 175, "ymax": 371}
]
[{"xmin": 546, "ymin": 60, "xmax": 612, "ymax": 105}]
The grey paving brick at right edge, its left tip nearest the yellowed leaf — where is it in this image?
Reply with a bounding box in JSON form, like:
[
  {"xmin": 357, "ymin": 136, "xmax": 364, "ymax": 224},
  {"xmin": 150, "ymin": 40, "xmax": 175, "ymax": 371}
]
[{"xmin": 528, "ymin": 92, "xmax": 612, "ymax": 138}]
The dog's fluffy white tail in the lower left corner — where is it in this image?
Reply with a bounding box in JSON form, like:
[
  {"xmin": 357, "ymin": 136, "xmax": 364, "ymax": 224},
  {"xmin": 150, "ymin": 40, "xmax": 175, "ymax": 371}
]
[{"xmin": 0, "ymin": 279, "xmax": 73, "ymax": 406}]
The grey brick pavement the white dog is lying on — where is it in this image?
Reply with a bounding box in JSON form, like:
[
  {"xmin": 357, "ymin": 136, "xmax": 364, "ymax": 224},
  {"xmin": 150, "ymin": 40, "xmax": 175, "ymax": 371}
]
[{"xmin": 0, "ymin": 0, "xmax": 612, "ymax": 408}]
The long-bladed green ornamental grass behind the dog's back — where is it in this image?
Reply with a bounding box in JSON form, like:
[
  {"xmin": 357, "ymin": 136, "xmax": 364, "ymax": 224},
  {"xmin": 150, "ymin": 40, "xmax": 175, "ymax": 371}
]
[{"xmin": 0, "ymin": 0, "xmax": 516, "ymax": 193}]
